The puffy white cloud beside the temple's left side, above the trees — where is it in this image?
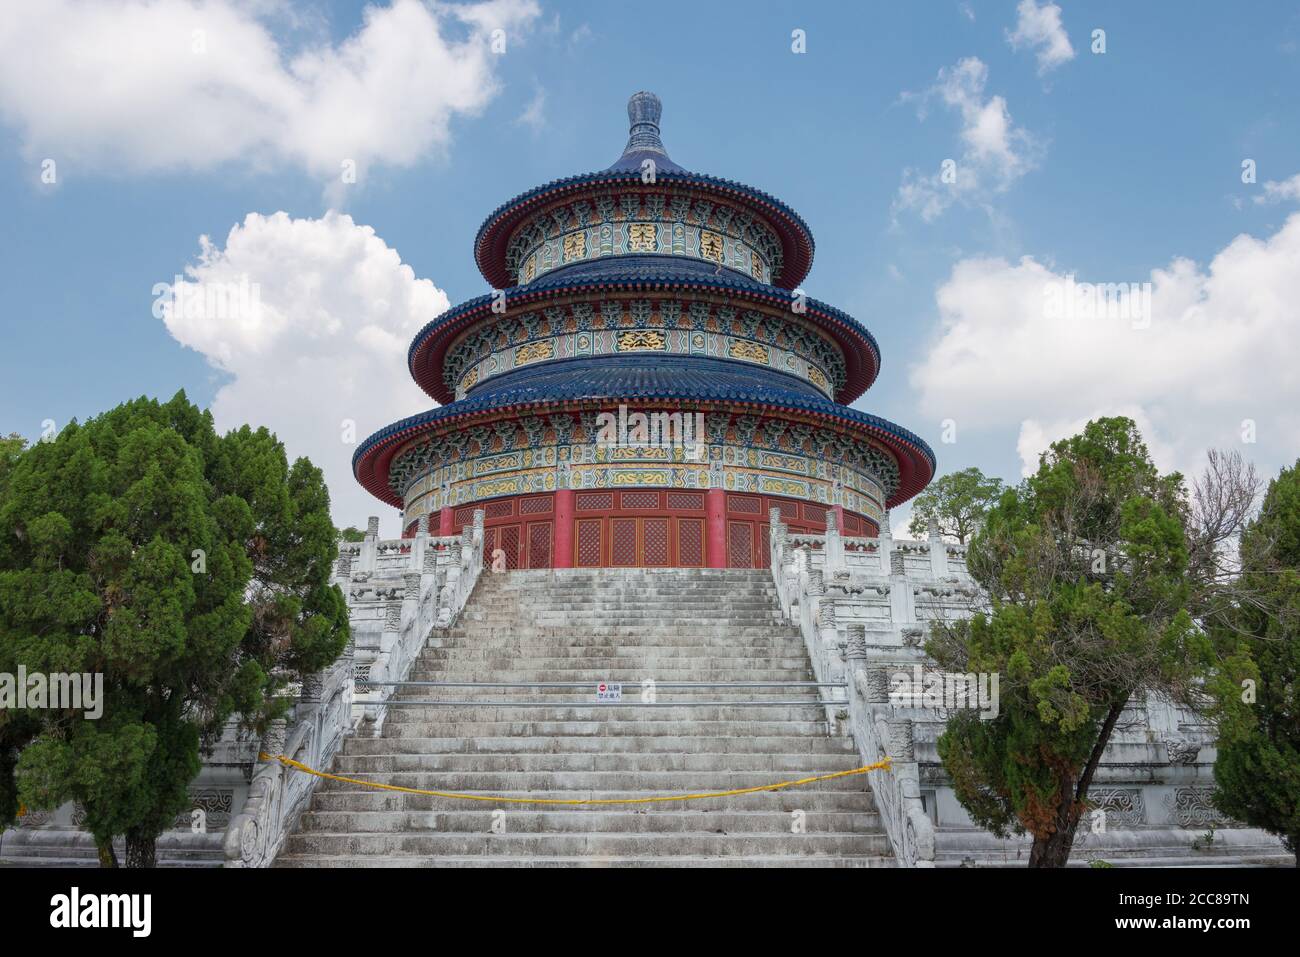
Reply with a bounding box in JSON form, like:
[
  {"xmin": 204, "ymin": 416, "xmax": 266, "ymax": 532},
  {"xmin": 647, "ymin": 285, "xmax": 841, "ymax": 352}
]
[{"xmin": 161, "ymin": 212, "xmax": 450, "ymax": 534}]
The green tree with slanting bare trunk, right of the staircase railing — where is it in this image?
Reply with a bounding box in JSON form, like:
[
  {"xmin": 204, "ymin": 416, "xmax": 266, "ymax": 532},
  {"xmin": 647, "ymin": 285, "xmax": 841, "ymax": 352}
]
[{"xmin": 927, "ymin": 419, "xmax": 1214, "ymax": 867}]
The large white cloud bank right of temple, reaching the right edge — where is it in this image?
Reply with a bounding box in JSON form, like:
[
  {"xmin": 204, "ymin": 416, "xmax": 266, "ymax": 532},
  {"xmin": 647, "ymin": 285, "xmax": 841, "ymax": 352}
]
[{"xmin": 911, "ymin": 213, "xmax": 1300, "ymax": 472}]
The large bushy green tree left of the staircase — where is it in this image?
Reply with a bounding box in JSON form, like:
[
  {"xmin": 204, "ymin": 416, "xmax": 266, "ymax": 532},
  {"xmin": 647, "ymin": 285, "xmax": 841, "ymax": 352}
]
[{"xmin": 0, "ymin": 393, "xmax": 347, "ymax": 866}]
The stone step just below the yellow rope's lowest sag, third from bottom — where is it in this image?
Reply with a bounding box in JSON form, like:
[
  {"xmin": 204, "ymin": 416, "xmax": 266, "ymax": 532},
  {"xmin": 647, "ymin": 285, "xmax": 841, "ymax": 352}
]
[{"xmin": 303, "ymin": 804, "xmax": 880, "ymax": 833}]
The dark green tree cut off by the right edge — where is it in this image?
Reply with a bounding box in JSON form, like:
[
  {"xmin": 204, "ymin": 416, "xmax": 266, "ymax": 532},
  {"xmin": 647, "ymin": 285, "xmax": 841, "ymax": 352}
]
[{"xmin": 1214, "ymin": 462, "xmax": 1300, "ymax": 863}]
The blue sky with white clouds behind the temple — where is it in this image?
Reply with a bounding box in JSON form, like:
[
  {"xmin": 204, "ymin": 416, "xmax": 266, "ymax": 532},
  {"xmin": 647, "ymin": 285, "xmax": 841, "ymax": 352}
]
[{"xmin": 0, "ymin": 0, "xmax": 1300, "ymax": 533}]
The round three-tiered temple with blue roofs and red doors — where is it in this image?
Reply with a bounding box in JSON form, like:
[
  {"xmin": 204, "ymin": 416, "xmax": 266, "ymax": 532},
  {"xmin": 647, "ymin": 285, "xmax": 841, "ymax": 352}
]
[{"xmin": 352, "ymin": 92, "xmax": 935, "ymax": 568}]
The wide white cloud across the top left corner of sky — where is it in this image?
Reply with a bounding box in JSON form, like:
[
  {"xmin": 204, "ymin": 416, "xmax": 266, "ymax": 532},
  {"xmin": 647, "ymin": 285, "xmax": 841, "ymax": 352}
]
[{"xmin": 0, "ymin": 0, "xmax": 538, "ymax": 188}]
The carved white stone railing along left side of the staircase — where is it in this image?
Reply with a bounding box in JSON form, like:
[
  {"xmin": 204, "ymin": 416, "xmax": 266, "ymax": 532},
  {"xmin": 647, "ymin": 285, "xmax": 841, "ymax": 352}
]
[{"xmin": 224, "ymin": 510, "xmax": 484, "ymax": 867}]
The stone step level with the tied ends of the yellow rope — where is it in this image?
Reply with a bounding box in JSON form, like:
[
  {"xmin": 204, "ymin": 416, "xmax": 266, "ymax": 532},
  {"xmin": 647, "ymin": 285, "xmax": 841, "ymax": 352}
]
[{"xmin": 334, "ymin": 752, "xmax": 859, "ymax": 780}]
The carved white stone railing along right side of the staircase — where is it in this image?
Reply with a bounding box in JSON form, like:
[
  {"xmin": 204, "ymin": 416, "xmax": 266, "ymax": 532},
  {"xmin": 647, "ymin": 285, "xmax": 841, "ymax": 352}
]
[{"xmin": 770, "ymin": 508, "xmax": 935, "ymax": 867}]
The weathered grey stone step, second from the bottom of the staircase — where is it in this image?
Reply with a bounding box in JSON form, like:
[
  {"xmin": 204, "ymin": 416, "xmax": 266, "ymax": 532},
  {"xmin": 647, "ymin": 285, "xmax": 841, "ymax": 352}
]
[{"xmin": 285, "ymin": 831, "xmax": 889, "ymax": 857}]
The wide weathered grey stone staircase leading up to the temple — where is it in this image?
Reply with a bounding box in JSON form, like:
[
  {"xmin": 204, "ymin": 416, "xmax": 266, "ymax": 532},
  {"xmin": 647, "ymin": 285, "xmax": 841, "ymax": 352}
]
[{"xmin": 276, "ymin": 568, "xmax": 893, "ymax": 867}]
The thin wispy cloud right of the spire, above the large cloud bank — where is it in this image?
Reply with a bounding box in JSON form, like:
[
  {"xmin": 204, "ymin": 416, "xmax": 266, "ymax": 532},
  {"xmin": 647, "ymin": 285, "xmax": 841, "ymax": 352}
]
[{"xmin": 893, "ymin": 56, "xmax": 1041, "ymax": 222}]
